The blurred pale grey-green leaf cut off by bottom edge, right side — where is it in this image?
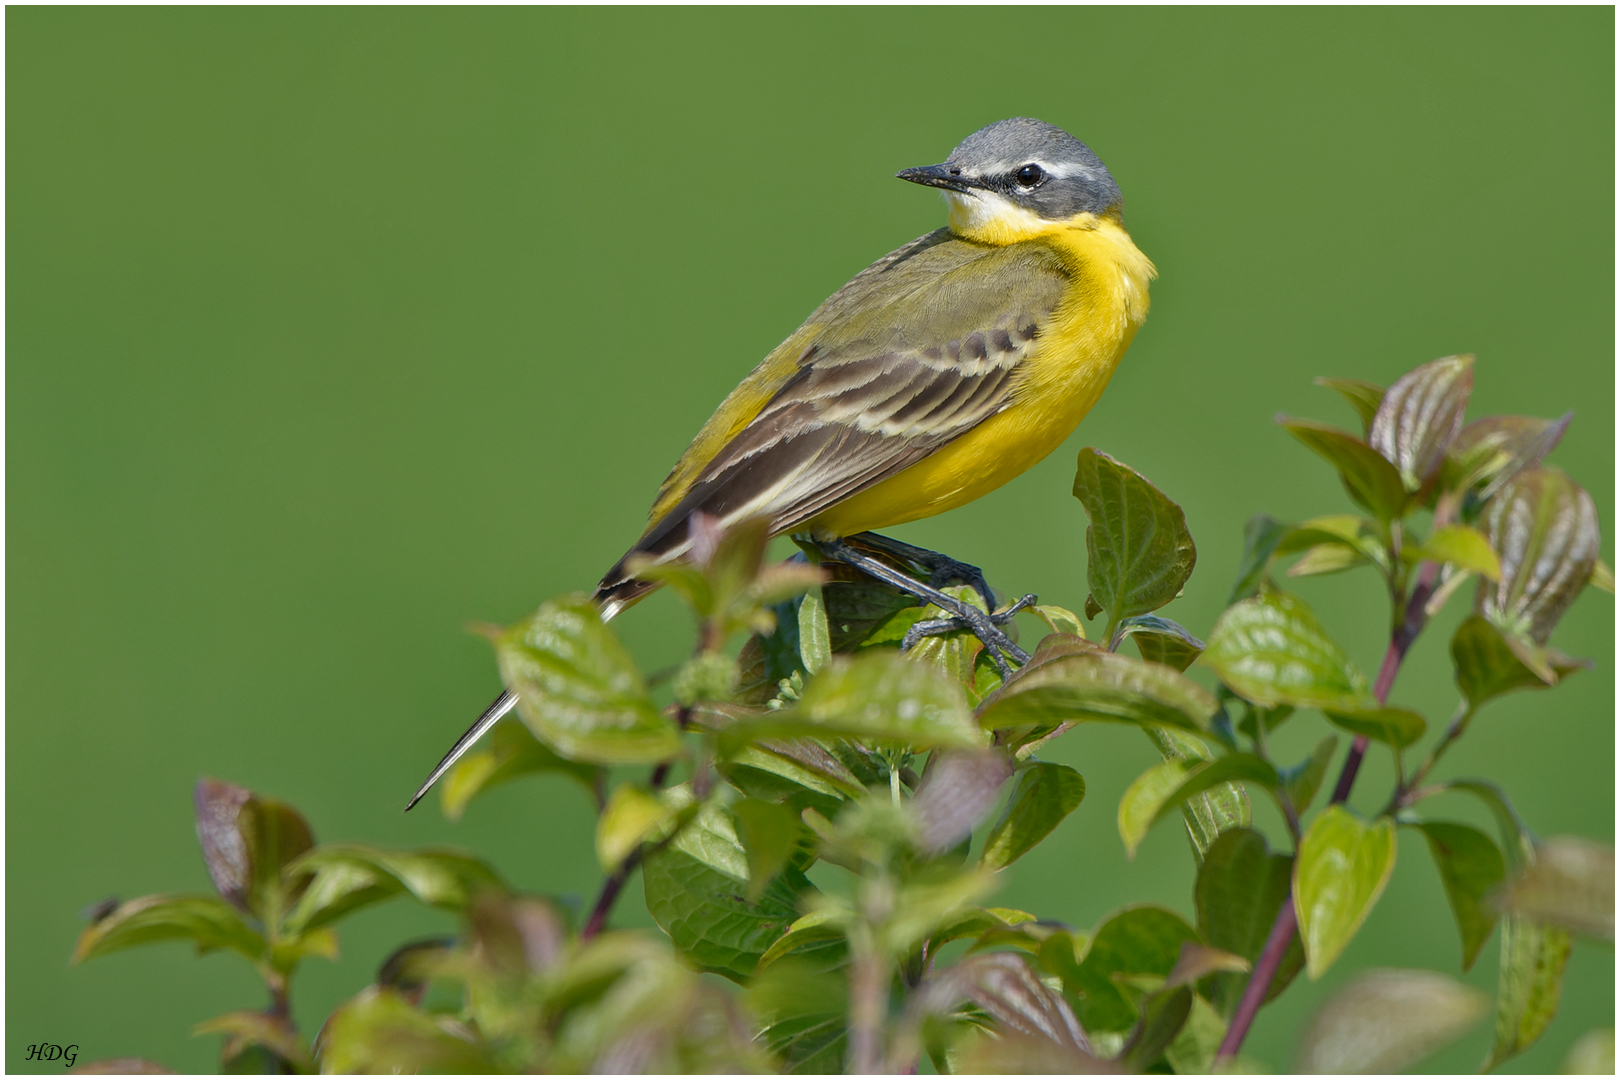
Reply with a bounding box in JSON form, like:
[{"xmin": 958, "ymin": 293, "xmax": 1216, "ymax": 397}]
[{"xmin": 1296, "ymin": 968, "xmax": 1489, "ymax": 1075}]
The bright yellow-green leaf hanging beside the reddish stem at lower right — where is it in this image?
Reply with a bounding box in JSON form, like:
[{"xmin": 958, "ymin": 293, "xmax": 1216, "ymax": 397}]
[{"xmin": 1294, "ymin": 805, "xmax": 1395, "ymax": 978}]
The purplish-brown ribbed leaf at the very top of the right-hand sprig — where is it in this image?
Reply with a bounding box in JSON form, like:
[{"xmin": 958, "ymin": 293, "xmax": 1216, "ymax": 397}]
[{"xmin": 1367, "ymin": 356, "xmax": 1474, "ymax": 491}]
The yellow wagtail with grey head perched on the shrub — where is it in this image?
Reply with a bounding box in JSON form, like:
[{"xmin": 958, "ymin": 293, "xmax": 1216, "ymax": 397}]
[{"xmin": 407, "ymin": 118, "xmax": 1157, "ymax": 810}]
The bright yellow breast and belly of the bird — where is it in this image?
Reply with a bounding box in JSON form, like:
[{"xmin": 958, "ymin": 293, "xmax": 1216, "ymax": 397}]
[{"xmin": 808, "ymin": 215, "xmax": 1157, "ymax": 538}]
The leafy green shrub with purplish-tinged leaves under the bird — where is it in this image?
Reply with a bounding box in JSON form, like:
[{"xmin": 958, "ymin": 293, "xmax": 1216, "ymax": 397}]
[{"xmin": 75, "ymin": 356, "xmax": 1614, "ymax": 1072}]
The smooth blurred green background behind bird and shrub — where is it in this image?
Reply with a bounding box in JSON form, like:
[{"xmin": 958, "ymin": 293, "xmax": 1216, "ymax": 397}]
[{"xmin": 5, "ymin": 8, "xmax": 1615, "ymax": 1072}]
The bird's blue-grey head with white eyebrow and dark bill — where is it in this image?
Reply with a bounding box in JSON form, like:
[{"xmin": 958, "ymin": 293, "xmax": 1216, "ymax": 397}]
[{"xmin": 896, "ymin": 117, "xmax": 1124, "ymax": 222}]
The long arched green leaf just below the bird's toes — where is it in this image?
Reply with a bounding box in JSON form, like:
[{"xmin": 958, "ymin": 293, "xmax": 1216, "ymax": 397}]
[{"xmin": 978, "ymin": 651, "xmax": 1218, "ymax": 732}]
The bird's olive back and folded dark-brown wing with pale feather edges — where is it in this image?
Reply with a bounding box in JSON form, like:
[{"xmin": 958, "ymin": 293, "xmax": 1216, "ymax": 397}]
[{"xmin": 599, "ymin": 230, "xmax": 1068, "ymax": 596}]
